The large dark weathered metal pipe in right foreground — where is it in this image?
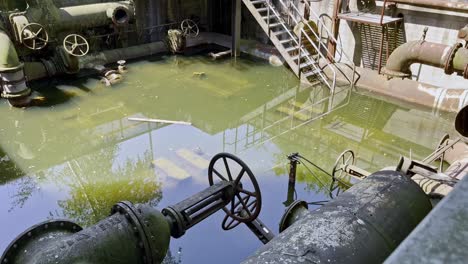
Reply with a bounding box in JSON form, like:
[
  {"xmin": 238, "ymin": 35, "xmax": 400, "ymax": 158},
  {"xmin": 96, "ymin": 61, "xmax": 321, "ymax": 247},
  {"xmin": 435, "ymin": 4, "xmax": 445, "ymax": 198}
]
[{"xmin": 243, "ymin": 171, "xmax": 432, "ymax": 264}]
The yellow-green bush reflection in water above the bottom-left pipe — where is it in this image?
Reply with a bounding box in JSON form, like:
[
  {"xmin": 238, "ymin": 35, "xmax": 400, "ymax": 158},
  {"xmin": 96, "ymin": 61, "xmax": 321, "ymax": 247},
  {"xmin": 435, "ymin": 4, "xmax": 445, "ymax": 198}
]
[{"xmin": 52, "ymin": 147, "xmax": 162, "ymax": 226}]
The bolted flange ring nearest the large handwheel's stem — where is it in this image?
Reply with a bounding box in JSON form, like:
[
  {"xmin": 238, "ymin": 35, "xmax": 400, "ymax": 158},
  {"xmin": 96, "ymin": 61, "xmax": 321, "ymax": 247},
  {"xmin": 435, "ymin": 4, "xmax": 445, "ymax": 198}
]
[{"xmin": 111, "ymin": 201, "xmax": 153, "ymax": 263}]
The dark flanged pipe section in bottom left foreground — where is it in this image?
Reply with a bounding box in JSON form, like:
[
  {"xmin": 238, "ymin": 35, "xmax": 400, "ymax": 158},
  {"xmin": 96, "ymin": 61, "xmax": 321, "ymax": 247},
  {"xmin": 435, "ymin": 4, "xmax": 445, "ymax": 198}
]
[{"xmin": 0, "ymin": 202, "xmax": 170, "ymax": 264}]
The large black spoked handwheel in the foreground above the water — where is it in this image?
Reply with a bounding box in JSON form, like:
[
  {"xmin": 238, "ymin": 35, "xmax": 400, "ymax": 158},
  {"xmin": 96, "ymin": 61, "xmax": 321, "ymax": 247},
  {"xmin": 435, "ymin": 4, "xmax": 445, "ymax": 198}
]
[{"xmin": 208, "ymin": 153, "xmax": 262, "ymax": 230}]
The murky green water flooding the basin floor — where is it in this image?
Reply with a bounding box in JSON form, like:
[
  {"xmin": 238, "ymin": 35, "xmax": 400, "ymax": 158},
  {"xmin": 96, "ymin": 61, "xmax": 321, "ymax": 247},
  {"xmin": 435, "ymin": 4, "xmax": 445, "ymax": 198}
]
[{"xmin": 0, "ymin": 56, "xmax": 452, "ymax": 263}]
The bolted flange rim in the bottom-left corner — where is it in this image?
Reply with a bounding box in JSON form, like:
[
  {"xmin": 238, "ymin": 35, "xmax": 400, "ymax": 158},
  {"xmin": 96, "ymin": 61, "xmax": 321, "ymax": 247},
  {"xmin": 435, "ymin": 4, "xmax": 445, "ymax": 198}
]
[{"xmin": 0, "ymin": 220, "xmax": 83, "ymax": 264}]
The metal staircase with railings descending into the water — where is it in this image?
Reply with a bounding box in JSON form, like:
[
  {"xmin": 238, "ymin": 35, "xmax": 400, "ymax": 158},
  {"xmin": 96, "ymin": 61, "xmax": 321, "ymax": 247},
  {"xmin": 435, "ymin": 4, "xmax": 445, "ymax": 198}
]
[{"xmin": 242, "ymin": 0, "xmax": 355, "ymax": 94}]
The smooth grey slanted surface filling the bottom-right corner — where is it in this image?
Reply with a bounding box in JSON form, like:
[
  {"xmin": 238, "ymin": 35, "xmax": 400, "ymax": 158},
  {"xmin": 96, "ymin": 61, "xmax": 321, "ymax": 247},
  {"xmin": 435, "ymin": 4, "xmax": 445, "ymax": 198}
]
[{"xmin": 385, "ymin": 174, "xmax": 468, "ymax": 264}]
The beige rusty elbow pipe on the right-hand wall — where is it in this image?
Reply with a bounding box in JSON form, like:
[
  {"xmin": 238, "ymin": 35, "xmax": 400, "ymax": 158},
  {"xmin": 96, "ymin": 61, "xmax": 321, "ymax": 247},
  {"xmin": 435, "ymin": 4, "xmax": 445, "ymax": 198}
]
[{"xmin": 383, "ymin": 41, "xmax": 468, "ymax": 78}]
